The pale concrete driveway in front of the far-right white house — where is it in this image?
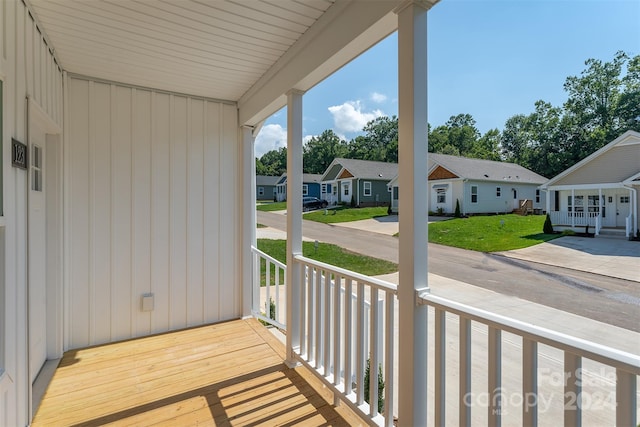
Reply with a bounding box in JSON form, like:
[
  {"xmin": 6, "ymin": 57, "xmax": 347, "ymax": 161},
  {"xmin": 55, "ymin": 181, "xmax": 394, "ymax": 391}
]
[{"xmin": 497, "ymin": 236, "xmax": 640, "ymax": 282}]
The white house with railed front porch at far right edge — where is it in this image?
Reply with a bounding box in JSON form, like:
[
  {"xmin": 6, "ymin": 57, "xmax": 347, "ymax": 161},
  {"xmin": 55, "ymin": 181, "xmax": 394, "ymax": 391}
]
[{"xmin": 542, "ymin": 131, "xmax": 640, "ymax": 237}]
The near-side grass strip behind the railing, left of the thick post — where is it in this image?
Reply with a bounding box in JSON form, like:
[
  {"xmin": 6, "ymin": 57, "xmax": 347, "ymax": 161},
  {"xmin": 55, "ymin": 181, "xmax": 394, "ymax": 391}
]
[{"xmin": 258, "ymin": 239, "xmax": 398, "ymax": 285}]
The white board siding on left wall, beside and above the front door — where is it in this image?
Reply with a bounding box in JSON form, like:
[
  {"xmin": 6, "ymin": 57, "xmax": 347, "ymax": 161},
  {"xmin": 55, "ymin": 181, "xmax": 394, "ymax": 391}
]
[{"xmin": 0, "ymin": 1, "xmax": 63, "ymax": 426}]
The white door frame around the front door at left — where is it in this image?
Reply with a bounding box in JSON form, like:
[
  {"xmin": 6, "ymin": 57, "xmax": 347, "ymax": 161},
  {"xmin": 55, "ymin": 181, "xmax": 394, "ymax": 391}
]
[{"xmin": 24, "ymin": 96, "xmax": 64, "ymax": 419}]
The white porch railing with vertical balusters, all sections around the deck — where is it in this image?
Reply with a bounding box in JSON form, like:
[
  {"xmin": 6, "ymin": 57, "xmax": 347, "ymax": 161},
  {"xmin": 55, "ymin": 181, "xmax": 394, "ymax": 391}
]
[{"xmin": 253, "ymin": 248, "xmax": 640, "ymax": 426}]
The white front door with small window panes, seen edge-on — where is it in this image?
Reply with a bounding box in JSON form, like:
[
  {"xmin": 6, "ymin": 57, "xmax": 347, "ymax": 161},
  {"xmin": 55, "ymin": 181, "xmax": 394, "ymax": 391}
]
[{"xmin": 28, "ymin": 122, "xmax": 47, "ymax": 382}]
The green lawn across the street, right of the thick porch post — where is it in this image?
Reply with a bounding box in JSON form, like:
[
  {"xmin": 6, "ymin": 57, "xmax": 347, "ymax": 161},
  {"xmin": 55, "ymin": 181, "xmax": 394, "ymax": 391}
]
[{"xmin": 429, "ymin": 215, "xmax": 561, "ymax": 252}]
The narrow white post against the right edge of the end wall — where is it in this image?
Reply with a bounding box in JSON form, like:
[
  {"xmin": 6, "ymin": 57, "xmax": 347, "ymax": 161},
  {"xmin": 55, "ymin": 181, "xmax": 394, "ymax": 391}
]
[{"xmin": 241, "ymin": 126, "xmax": 256, "ymax": 318}]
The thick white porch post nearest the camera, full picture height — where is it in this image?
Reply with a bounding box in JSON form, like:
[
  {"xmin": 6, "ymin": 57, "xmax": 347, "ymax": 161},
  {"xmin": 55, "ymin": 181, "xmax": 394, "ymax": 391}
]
[{"xmin": 396, "ymin": 1, "xmax": 431, "ymax": 426}]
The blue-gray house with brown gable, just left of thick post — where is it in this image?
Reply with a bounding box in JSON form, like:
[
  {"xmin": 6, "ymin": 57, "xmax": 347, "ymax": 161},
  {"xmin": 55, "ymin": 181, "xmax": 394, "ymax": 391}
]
[{"xmin": 321, "ymin": 158, "xmax": 398, "ymax": 207}]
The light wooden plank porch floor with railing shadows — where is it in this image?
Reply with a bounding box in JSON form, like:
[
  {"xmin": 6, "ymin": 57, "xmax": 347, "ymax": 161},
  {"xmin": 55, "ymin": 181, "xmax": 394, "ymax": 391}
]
[{"xmin": 32, "ymin": 319, "xmax": 362, "ymax": 427}]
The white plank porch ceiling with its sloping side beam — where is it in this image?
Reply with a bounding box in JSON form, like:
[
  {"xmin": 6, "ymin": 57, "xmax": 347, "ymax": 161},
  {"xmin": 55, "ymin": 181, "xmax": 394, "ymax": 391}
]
[{"xmin": 27, "ymin": 0, "xmax": 401, "ymax": 126}]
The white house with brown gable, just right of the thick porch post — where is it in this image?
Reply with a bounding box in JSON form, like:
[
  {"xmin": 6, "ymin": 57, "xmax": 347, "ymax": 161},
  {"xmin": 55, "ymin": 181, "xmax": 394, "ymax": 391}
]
[{"xmin": 389, "ymin": 153, "xmax": 547, "ymax": 215}]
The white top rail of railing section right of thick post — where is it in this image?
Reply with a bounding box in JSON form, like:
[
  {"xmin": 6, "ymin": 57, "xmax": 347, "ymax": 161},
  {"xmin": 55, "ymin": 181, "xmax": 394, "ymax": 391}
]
[{"xmin": 419, "ymin": 292, "xmax": 640, "ymax": 375}]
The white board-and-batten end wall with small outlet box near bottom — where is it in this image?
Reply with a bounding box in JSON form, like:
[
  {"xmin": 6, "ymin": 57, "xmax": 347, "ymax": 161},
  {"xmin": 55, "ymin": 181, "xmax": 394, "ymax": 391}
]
[{"xmin": 65, "ymin": 76, "xmax": 242, "ymax": 348}]
